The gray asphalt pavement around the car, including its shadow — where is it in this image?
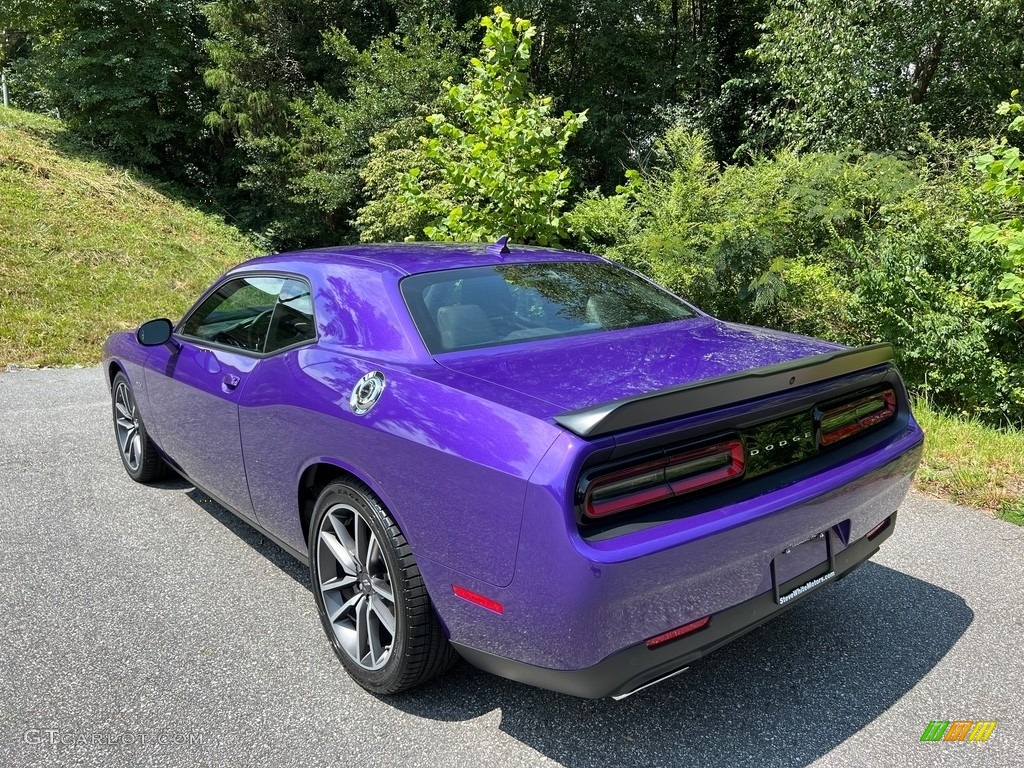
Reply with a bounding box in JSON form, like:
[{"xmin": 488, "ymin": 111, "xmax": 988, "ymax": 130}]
[{"xmin": 0, "ymin": 369, "xmax": 1024, "ymax": 768}]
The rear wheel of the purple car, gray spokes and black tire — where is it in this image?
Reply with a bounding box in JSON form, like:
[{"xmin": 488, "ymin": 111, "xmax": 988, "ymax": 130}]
[{"xmin": 309, "ymin": 480, "xmax": 458, "ymax": 694}]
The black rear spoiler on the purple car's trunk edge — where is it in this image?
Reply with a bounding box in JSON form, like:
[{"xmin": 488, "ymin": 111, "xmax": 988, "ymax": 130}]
[{"xmin": 555, "ymin": 344, "xmax": 893, "ymax": 437}]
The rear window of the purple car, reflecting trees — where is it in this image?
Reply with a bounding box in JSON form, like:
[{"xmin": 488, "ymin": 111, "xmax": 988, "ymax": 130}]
[{"xmin": 401, "ymin": 261, "xmax": 693, "ymax": 354}]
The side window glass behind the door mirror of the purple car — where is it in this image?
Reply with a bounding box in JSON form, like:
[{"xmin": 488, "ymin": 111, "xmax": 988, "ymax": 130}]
[{"xmin": 181, "ymin": 276, "xmax": 316, "ymax": 353}]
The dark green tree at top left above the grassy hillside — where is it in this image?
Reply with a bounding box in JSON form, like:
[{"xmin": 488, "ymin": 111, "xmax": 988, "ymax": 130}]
[{"xmin": 23, "ymin": 0, "xmax": 206, "ymax": 166}]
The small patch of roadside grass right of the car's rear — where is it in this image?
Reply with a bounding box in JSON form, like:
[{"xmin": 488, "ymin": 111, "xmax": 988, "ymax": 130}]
[{"xmin": 913, "ymin": 400, "xmax": 1024, "ymax": 525}]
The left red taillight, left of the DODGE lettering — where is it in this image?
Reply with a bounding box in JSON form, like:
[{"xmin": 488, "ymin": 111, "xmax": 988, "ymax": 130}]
[{"xmin": 583, "ymin": 438, "xmax": 744, "ymax": 518}]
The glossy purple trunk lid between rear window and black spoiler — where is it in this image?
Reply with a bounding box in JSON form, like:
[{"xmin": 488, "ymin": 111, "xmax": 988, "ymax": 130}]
[{"xmin": 435, "ymin": 317, "xmax": 845, "ymax": 411}]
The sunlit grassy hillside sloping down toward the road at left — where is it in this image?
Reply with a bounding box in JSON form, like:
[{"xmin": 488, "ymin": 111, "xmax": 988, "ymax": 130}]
[{"xmin": 0, "ymin": 108, "xmax": 257, "ymax": 371}]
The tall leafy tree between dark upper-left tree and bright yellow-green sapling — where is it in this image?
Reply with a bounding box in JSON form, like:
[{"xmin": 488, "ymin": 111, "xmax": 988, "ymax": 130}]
[{"xmin": 204, "ymin": 0, "xmax": 478, "ymax": 248}]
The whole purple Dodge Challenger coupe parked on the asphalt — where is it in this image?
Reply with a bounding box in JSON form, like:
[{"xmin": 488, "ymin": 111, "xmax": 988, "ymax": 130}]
[{"xmin": 103, "ymin": 239, "xmax": 924, "ymax": 697}]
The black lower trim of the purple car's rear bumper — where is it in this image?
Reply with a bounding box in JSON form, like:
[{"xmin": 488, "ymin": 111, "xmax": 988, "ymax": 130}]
[{"xmin": 453, "ymin": 512, "xmax": 896, "ymax": 698}]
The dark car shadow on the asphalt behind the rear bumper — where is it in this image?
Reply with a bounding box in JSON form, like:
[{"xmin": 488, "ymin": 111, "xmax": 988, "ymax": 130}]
[{"xmin": 386, "ymin": 562, "xmax": 974, "ymax": 766}]
